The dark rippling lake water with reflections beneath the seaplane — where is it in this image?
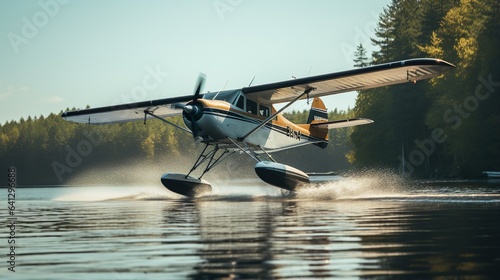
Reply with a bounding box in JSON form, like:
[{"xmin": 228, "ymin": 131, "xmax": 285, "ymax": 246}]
[{"xmin": 0, "ymin": 174, "xmax": 500, "ymax": 280}]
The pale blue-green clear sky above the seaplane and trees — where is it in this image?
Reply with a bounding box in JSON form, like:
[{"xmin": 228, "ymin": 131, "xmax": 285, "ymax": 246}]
[{"xmin": 0, "ymin": 0, "xmax": 390, "ymax": 124}]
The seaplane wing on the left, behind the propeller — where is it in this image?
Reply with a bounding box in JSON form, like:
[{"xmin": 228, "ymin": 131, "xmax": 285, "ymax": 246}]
[{"xmin": 62, "ymin": 95, "xmax": 193, "ymax": 124}]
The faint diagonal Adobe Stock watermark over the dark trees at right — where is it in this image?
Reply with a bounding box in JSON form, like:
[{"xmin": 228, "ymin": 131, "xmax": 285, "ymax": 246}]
[{"xmin": 398, "ymin": 74, "xmax": 500, "ymax": 175}]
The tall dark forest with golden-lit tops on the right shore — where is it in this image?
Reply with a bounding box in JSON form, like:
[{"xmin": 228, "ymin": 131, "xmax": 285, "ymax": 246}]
[{"xmin": 349, "ymin": 0, "xmax": 500, "ymax": 178}]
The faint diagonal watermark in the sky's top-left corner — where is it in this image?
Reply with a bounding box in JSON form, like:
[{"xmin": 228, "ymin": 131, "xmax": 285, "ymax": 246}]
[{"xmin": 7, "ymin": 0, "xmax": 69, "ymax": 53}]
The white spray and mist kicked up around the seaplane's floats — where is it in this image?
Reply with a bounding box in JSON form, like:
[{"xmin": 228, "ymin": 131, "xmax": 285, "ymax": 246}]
[{"xmin": 50, "ymin": 155, "xmax": 500, "ymax": 201}]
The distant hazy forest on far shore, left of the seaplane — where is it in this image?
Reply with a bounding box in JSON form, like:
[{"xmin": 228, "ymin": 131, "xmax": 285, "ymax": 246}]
[{"xmin": 0, "ymin": 108, "xmax": 193, "ymax": 185}]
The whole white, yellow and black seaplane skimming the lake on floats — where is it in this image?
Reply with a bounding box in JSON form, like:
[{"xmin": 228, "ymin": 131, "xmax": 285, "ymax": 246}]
[{"xmin": 62, "ymin": 58, "xmax": 455, "ymax": 197}]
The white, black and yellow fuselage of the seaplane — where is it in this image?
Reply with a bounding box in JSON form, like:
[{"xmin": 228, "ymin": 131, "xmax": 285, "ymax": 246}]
[{"xmin": 183, "ymin": 92, "xmax": 328, "ymax": 153}]
